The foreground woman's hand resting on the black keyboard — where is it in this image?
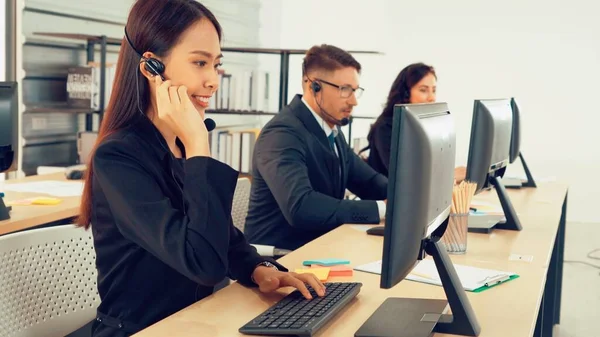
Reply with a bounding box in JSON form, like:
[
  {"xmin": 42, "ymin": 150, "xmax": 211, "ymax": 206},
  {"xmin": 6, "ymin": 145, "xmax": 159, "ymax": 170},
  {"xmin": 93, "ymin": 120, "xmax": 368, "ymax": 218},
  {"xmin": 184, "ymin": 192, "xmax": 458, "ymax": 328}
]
[{"xmin": 252, "ymin": 266, "xmax": 325, "ymax": 300}]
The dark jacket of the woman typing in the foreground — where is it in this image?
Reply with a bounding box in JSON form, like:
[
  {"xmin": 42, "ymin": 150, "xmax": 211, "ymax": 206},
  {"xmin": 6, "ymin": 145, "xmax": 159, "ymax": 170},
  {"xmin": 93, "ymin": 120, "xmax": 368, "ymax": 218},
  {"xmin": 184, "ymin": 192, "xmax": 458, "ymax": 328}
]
[{"xmin": 89, "ymin": 116, "xmax": 283, "ymax": 337}]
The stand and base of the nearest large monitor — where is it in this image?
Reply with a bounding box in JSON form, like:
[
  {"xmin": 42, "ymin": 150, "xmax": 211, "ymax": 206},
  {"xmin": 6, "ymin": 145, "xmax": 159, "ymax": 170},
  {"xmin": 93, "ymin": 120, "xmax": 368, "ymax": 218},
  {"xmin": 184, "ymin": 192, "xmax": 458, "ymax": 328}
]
[{"xmin": 354, "ymin": 239, "xmax": 481, "ymax": 337}]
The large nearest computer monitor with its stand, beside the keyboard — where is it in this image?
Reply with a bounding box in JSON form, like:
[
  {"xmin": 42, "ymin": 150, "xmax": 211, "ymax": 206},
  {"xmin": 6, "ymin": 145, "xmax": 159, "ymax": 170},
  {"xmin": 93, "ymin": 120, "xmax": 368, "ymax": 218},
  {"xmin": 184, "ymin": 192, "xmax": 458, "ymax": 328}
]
[{"xmin": 355, "ymin": 103, "xmax": 481, "ymax": 337}]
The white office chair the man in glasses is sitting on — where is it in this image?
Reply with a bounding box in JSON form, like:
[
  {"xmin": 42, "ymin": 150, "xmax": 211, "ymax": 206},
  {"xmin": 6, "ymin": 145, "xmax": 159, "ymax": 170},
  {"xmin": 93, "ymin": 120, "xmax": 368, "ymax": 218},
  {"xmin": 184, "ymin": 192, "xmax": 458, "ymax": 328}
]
[{"xmin": 231, "ymin": 178, "xmax": 289, "ymax": 257}]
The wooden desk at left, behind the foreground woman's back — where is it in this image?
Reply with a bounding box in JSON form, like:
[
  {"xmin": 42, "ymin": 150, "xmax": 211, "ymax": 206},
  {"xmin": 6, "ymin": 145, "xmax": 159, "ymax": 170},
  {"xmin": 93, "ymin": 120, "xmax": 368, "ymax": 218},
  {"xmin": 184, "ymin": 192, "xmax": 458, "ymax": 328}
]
[{"xmin": 0, "ymin": 173, "xmax": 81, "ymax": 235}]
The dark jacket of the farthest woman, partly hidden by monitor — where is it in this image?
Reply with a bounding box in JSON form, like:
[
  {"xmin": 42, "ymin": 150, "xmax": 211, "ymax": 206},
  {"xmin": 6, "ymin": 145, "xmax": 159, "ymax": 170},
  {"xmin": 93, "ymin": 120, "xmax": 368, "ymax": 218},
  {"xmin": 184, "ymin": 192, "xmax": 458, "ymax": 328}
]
[{"xmin": 367, "ymin": 117, "xmax": 392, "ymax": 177}]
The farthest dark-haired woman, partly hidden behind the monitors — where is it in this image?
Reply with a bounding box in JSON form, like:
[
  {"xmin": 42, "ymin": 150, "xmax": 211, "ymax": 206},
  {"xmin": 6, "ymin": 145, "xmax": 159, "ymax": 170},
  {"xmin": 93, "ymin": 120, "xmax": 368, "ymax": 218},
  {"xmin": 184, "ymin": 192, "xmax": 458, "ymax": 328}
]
[{"xmin": 367, "ymin": 63, "xmax": 466, "ymax": 182}]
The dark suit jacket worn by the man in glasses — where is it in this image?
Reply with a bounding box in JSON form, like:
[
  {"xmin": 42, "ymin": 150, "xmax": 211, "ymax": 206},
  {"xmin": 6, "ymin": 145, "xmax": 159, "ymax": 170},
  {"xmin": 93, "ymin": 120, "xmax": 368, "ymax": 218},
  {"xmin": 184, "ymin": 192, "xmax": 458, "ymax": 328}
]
[{"xmin": 244, "ymin": 95, "xmax": 387, "ymax": 249}]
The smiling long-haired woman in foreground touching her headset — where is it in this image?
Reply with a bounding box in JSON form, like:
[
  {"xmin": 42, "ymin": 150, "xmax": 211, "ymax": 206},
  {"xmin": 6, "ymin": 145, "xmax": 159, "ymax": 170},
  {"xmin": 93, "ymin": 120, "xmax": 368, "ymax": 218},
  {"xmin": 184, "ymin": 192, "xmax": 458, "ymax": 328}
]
[{"xmin": 78, "ymin": 0, "xmax": 325, "ymax": 336}]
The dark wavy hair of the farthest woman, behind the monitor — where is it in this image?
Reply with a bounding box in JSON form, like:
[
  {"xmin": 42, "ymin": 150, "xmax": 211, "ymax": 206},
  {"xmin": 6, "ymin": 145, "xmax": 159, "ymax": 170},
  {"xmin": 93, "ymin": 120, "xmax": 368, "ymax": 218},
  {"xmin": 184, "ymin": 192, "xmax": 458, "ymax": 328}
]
[{"xmin": 367, "ymin": 63, "xmax": 437, "ymax": 140}]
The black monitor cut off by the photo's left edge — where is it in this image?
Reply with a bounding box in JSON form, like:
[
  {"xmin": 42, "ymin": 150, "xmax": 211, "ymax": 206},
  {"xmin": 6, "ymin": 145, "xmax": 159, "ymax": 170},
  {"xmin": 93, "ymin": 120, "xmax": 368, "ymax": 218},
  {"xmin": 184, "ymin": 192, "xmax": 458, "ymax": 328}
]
[{"xmin": 0, "ymin": 82, "xmax": 19, "ymax": 220}]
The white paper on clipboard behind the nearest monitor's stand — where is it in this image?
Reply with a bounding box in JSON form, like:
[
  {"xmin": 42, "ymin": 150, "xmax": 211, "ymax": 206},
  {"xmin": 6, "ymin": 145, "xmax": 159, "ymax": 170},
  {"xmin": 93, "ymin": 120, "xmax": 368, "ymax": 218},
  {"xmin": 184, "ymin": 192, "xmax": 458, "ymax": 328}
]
[{"xmin": 354, "ymin": 259, "xmax": 519, "ymax": 292}]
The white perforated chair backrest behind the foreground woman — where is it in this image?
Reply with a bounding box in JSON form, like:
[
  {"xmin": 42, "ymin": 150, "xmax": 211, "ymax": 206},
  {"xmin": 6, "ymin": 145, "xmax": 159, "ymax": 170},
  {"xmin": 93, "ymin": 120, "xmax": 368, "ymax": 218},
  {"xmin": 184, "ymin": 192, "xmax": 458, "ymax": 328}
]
[{"xmin": 0, "ymin": 225, "xmax": 100, "ymax": 337}]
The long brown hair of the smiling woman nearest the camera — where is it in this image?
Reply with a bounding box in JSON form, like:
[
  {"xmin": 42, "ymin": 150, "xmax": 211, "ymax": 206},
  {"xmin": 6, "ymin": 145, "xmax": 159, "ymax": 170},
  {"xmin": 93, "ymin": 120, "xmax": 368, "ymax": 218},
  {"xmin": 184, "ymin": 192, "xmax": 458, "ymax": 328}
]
[{"xmin": 76, "ymin": 0, "xmax": 222, "ymax": 229}]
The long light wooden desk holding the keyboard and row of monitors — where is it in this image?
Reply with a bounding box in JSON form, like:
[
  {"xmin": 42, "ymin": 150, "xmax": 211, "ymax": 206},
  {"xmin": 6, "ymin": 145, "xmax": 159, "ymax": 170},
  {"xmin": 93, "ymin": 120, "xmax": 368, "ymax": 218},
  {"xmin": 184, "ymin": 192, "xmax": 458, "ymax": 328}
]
[{"xmin": 136, "ymin": 183, "xmax": 567, "ymax": 337}]
